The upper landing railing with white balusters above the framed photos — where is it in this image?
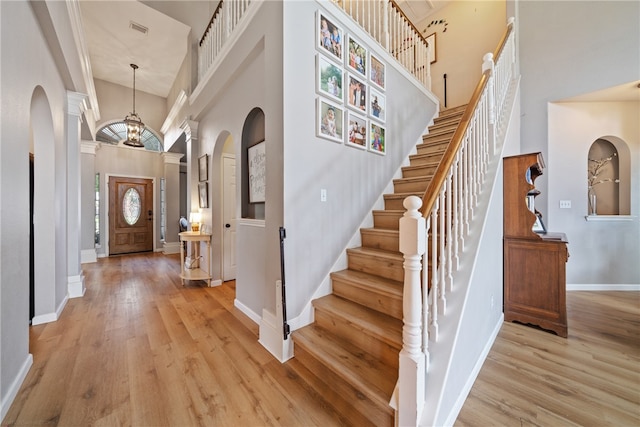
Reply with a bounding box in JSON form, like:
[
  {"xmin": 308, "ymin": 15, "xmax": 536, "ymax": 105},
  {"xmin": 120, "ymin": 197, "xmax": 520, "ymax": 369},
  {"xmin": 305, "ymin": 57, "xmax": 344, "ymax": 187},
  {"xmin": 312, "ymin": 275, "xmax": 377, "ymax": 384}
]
[{"xmin": 332, "ymin": 0, "xmax": 431, "ymax": 89}]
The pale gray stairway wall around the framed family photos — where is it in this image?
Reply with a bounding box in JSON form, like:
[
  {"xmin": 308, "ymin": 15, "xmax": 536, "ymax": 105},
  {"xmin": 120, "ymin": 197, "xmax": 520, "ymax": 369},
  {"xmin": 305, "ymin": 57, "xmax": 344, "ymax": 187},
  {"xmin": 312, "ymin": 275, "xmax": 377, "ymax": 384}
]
[{"xmin": 282, "ymin": 1, "xmax": 437, "ymax": 318}]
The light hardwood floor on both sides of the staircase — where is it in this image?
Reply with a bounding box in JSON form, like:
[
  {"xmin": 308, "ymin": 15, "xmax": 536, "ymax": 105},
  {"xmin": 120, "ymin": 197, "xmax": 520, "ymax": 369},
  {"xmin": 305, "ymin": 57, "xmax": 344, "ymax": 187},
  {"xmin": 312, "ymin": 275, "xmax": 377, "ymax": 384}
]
[{"xmin": 2, "ymin": 254, "xmax": 640, "ymax": 426}]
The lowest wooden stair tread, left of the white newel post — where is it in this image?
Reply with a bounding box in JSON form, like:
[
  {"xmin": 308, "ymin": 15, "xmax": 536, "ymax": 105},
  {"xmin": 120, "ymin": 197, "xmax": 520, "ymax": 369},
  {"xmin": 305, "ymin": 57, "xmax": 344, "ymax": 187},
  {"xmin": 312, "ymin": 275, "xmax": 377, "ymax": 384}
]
[{"xmin": 294, "ymin": 324, "xmax": 398, "ymax": 418}]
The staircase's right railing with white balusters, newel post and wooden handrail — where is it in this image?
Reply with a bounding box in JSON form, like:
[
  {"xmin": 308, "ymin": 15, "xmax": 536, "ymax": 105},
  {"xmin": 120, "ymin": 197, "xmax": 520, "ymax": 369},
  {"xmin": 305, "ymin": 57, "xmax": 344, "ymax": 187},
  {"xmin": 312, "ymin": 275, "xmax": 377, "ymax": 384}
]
[{"xmin": 397, "ymin": 18, "xmax": 516, "ymax": 425}]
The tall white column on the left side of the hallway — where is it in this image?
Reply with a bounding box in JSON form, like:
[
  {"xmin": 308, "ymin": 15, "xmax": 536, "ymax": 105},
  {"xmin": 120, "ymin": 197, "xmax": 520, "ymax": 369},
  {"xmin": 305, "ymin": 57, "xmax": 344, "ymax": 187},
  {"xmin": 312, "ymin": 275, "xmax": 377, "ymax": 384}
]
[{"xmin": 66, "ymin": 91, "xmax": 87, "ymax": 298}]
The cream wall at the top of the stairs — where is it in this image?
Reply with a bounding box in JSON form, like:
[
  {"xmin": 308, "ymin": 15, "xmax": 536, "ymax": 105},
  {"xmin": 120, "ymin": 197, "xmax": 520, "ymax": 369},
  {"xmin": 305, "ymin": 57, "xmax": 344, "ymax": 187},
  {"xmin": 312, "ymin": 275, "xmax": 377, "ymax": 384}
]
[{"xmin": 416, "ymin": 0, "xmax": 507, "ymax": 108}]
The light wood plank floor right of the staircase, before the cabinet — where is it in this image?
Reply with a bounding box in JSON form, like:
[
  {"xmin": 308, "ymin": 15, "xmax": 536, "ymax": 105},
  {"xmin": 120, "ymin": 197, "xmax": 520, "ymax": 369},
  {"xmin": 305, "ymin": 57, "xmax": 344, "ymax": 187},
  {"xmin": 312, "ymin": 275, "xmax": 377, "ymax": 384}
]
[{"xmin": 455, "ymin": 291, "xmax": 640, "ymax": 427}]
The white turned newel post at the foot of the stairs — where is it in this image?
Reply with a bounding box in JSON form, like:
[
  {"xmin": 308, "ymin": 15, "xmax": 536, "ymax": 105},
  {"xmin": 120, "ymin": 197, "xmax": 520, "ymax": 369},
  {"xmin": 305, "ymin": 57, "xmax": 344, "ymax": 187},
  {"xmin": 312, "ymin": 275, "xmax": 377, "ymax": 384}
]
[{"xmin": 398, "ymin": 196, "xmax": 426, "ymax": 426}]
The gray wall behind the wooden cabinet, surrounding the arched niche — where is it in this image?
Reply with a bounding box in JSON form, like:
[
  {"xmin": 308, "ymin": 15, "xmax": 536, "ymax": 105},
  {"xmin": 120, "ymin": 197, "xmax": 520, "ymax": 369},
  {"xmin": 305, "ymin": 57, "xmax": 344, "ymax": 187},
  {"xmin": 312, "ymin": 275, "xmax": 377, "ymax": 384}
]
[{"xmin": 518, "ymin": 1, "xmax": 640, "ymax": 285}]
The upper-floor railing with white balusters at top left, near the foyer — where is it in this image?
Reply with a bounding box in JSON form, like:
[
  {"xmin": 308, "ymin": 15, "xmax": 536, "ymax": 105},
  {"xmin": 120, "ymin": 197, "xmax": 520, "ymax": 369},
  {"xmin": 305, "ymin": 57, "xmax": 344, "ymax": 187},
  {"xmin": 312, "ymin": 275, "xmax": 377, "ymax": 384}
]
[{"xmin": 198, "ymin": 0, "xmax": 255, "ymax": 82}]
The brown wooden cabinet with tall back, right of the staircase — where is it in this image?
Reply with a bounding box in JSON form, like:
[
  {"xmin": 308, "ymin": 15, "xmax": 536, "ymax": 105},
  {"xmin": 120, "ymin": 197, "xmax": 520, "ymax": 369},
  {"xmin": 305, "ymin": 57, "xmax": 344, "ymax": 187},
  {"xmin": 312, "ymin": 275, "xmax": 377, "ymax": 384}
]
[{"xmin": 503, "ymin": 153, "xmax": 568, "ymax": 337}]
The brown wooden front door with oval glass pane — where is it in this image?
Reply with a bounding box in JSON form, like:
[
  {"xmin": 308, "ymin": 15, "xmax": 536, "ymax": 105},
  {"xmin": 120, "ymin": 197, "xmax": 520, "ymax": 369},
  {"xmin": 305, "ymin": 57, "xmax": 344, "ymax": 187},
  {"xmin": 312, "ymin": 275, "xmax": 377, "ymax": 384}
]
[{"xmin": 109, "ymin": 177, "xmax": 153, "ymax": 255}]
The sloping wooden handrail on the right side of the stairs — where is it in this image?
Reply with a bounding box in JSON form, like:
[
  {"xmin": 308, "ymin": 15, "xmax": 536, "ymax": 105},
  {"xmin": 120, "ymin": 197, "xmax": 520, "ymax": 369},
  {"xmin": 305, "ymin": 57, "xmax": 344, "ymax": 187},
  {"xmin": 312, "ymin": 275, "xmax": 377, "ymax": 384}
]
[{"xmin": 418, "ymin": 22, "xmax": 513, "ymax": 218}]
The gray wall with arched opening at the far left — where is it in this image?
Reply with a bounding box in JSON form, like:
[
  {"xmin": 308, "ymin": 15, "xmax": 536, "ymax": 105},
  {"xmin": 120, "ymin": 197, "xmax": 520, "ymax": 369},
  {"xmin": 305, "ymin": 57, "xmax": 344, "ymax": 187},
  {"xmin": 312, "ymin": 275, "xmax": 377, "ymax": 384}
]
[{"xmin": 0, "ymin": 2, "xmax": 67, "ymax": 416}]
